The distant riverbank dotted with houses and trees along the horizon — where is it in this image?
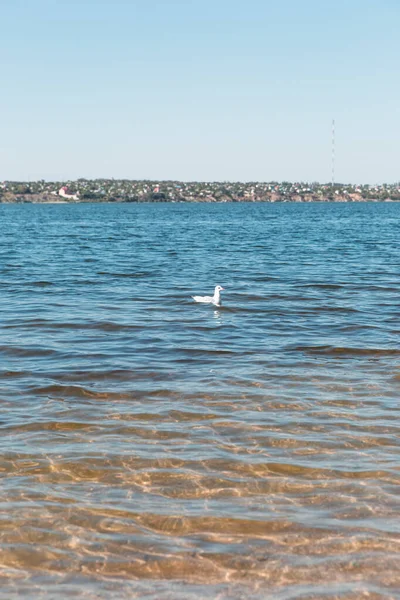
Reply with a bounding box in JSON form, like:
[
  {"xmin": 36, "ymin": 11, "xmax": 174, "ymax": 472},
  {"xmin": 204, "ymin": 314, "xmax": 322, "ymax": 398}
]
[{"xmin": 0, "ymin": 179, "xmax": 400, "ymax": 204}]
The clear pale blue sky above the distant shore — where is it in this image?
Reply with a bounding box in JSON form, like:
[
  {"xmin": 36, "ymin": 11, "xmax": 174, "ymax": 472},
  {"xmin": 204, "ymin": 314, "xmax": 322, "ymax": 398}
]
[{"xmin": 0, "ymin": 0, "xmax": 400, "ymax": 184}]
